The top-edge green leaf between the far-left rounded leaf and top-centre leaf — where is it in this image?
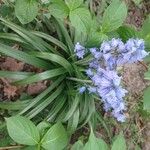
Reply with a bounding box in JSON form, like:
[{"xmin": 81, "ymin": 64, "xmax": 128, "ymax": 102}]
[{"xmin": 49, "ymin": 0, "xmax": 69, "ymax": 19}]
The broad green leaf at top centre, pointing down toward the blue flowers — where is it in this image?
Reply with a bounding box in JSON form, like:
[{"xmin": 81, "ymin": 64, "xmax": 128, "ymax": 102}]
[{"xmin": 69, "ymin": 8, "xmax": 92, "ymax": 32}]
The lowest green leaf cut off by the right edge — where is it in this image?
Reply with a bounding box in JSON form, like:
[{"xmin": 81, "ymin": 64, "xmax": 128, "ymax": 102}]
[{"xmin": 143, "ymin": 87, "xmax": 150, "ymax": 112}]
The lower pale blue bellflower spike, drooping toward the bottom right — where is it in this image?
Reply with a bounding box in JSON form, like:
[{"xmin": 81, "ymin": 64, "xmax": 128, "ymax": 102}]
[{"xmin": 91, "ymin": 68, "xmax": 127, "ymax": 122}]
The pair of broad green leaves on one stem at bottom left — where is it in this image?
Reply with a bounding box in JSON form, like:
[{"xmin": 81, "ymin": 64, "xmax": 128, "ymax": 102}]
[{"xmin": 6, "ymin": 116, "xmax": 68, "ymax": 150}]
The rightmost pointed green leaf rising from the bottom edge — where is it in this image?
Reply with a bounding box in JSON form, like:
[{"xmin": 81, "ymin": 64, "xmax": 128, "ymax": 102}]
[{"xmin": 111, "ymin": 133, "xmax": 127, "ymax": 150}]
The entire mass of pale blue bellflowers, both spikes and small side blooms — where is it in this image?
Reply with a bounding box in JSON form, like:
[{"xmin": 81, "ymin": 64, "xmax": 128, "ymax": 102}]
[{"xmin": 75, "ymin": 38, "xmax": 148, "ymax": 122}]
